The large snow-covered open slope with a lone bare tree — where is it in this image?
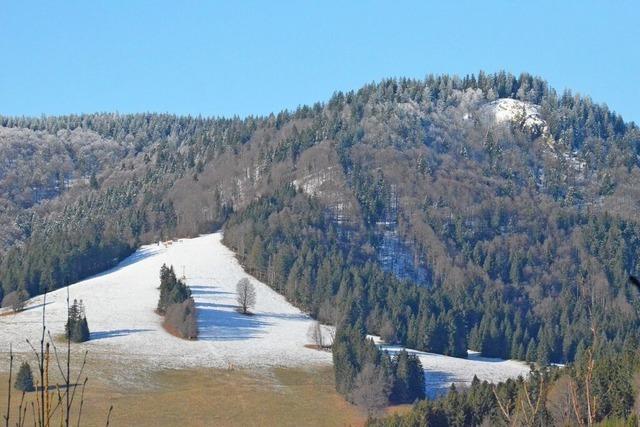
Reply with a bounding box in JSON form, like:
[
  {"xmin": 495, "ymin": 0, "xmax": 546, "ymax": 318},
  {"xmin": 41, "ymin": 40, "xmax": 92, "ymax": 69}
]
[{"xmin": 0, "ymin": 233, "xmax": 331, "ymax": 368}]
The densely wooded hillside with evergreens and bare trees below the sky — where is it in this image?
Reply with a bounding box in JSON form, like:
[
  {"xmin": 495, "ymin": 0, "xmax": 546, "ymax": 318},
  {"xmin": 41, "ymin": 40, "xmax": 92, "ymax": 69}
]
[{"xmin": 0, "ymin": 73, "xmax": 640, "ymax": 362}]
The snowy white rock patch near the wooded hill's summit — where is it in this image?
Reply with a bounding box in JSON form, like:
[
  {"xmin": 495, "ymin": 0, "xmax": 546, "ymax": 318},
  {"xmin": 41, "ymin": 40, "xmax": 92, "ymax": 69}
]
[{"xmin": 485, "ymin": 98, "xmax": 549, "ymax": 135}]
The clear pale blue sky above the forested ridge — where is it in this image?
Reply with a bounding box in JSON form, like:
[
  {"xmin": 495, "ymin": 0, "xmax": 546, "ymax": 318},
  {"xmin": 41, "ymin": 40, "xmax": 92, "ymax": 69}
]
[{"xmin": 0, "ymin": 0, "xmax": 640, "ymax": 122}]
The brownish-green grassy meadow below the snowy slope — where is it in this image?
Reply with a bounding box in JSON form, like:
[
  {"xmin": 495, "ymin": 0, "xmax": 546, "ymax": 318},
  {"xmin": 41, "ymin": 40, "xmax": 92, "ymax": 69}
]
[{"xmin": 0, "ymin": 368, "xmax": 365, "ymax": 426}]
